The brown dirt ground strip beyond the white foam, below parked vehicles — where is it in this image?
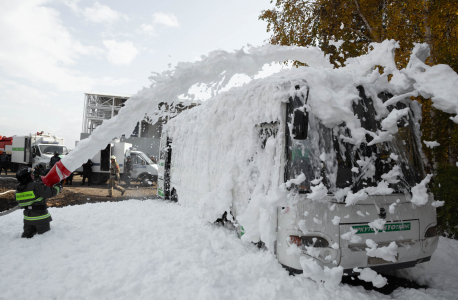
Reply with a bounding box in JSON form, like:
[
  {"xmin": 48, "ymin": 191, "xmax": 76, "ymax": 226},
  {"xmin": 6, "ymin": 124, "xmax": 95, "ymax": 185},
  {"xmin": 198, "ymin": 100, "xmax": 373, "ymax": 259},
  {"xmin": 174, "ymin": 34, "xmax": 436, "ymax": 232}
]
[{"xmin": 0, "ymin": 173, "xmax": 157, "ymax": 212}]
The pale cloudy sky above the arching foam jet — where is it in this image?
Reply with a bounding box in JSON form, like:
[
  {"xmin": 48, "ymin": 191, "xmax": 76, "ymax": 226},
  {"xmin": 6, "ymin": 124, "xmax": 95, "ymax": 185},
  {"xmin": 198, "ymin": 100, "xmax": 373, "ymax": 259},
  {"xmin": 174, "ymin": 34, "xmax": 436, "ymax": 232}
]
[{"xmin": 0, "ymin": 0, "xmax": 272, "ymax": 149}]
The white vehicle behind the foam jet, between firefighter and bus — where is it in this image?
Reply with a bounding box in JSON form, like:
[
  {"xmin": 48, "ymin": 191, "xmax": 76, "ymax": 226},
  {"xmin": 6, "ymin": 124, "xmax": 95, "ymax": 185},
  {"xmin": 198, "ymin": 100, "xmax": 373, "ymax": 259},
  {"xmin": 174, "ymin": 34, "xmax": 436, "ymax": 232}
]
[{"xmin": 75, "ymin": 140, "xmax": 157, "ymax": 184}]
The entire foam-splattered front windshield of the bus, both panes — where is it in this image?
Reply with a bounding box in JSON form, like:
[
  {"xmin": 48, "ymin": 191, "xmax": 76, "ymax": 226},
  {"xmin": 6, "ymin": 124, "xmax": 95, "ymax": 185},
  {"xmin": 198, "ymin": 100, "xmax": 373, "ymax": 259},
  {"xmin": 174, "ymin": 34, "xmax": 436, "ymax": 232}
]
[{"xmin": 285, "ymin": 87, "xmax": 425, "ymax": 193}]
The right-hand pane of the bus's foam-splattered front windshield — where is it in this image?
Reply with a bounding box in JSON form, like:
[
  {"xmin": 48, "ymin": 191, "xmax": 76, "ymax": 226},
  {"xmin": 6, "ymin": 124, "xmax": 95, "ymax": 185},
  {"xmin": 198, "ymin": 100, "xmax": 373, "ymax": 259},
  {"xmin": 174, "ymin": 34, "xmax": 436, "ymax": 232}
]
[{"xmin": 333, "ymin": 88, "xmax": 425, "ymax": 193}]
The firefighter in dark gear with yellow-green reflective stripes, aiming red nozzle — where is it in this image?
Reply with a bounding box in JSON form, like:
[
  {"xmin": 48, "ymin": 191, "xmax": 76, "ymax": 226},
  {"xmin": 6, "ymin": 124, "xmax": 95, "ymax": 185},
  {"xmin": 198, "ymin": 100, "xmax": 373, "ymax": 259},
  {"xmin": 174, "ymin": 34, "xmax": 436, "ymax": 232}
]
[{"xmin": 15, "ymin": 168, "xmax": 62, "ymax": 238}]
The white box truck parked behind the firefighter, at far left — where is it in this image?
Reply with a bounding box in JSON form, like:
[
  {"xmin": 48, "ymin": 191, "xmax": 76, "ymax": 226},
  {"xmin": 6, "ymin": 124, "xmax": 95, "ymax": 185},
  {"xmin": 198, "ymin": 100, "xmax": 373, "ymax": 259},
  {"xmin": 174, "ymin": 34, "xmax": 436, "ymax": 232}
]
[{"xmin": 10, "ymin": 133, "xmax": 68, "ymax": 172}]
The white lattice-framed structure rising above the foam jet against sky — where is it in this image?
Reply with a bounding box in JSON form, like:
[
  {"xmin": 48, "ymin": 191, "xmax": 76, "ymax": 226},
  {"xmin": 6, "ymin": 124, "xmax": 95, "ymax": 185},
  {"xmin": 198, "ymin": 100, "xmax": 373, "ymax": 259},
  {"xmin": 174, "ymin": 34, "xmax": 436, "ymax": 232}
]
[{"xmin": 82, "ymin": 93, "xmax": 131, "ymax": 134}]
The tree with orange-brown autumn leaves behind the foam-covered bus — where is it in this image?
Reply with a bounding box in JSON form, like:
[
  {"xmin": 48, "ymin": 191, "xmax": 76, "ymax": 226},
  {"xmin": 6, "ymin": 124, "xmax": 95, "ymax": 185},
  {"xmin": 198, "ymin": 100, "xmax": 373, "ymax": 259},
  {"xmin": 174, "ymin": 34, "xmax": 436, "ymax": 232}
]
[{"xmin": 259, "ymin": 0, "xmax": 458, "ymax": 71}]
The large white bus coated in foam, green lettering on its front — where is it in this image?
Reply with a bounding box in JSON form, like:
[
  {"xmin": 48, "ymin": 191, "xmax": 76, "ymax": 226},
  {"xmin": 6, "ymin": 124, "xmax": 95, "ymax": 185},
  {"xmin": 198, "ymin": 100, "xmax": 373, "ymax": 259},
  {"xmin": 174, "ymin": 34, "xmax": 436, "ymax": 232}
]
[{"xmin": 158, "ymin": 77, "xmax": 438, "ymax": 274}]
